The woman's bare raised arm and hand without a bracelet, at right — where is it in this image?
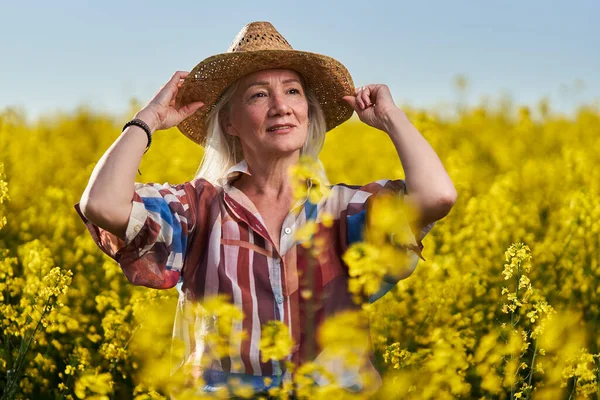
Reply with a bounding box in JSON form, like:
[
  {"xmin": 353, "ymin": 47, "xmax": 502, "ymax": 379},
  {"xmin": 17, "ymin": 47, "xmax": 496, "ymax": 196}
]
[{"xmin": 344, "ymin": 85, "xmax": 457, "ymax": 232}]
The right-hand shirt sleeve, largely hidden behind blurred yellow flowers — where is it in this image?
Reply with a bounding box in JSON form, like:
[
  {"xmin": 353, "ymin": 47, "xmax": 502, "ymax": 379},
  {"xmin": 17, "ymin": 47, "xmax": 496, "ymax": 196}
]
[{"xmin": 332, "ymin": 179, "xmax": 436, "ymax": 302}]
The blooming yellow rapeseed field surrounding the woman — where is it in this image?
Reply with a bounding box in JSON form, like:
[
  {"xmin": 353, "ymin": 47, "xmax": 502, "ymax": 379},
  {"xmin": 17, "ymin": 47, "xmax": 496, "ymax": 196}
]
[{"xmin": 0, "ymin": 96, "xmax": 600, "ymax": 399}]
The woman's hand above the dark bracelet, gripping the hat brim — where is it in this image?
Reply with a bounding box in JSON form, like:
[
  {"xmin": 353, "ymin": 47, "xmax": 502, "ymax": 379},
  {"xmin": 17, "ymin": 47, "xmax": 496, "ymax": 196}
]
[{"xmin": 135, "ymin": 71, "xmax": 204, "ymax": 132}]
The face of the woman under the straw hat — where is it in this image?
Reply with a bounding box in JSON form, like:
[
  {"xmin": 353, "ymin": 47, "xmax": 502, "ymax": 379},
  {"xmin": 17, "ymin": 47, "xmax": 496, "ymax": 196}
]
[{"xmin": 225, "ymin": 69, "xmax": 308, "ymax": 157}]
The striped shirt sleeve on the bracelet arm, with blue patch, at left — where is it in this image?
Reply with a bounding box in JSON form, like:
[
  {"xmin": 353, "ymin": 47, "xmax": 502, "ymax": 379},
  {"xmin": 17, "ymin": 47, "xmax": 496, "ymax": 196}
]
[{"xmin": 75, "ymin": 179, "xmax": 210, "ymax": 289}]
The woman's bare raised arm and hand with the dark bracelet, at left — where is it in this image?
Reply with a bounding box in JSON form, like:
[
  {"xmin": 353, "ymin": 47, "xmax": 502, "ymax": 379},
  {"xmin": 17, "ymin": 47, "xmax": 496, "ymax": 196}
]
[{"xmin": 80, "ymin": 71, "xmax": 204, "ymax": 239}]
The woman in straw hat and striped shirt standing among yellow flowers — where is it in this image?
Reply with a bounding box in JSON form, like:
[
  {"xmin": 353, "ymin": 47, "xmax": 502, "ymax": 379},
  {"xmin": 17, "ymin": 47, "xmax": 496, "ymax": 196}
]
[{"xmin": 76, "ymin": 22, "xmax": 456, "ymax": 392}]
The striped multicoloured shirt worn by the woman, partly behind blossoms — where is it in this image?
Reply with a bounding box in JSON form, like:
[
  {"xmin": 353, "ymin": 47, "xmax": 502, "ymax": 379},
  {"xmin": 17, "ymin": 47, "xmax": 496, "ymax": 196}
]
[{"xmin": 75, "ymin": 161, "xmax": 435, "ymax": 394}]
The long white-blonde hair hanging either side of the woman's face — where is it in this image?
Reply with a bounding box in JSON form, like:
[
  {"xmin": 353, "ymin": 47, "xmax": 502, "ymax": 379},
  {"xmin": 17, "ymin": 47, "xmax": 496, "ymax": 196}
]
[{"xmin": 195, "ymin": 70, "xmax": 327, "ymax": 185}]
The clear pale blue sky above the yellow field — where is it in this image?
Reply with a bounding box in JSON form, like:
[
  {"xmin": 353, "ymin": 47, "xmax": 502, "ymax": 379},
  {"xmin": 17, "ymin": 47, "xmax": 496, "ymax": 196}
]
[{"xmin": 0, "ymin": 0, "xmax": 600, "ymax": 118}]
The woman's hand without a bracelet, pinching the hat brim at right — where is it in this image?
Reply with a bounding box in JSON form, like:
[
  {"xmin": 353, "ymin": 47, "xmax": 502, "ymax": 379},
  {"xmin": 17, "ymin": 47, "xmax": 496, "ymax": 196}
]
[{"xmin": 343, "ymin": 84, "xmax": 405, "ymax": 132}]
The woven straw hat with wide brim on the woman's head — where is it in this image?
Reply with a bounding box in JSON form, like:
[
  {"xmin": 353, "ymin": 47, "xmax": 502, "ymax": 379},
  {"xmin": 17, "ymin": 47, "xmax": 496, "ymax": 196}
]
[{"xmin": 175, "ymin": 22, "xmax": 354, "ymax": 145}]
